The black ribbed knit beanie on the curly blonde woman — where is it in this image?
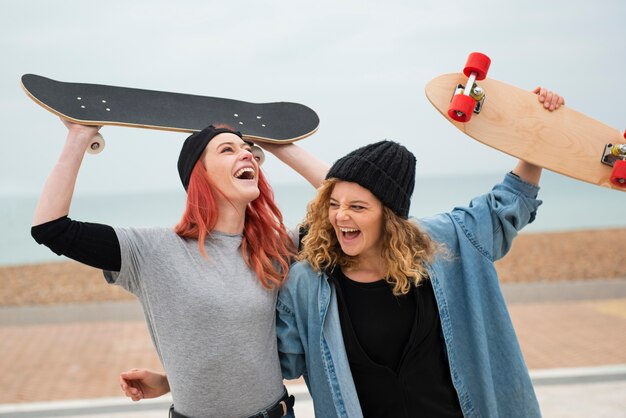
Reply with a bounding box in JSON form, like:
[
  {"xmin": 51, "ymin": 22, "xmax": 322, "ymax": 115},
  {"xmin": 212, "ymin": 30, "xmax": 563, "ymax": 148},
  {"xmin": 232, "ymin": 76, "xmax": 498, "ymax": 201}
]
[{"xmin": 326, "ymin": 141, "xmax": 415, "ymax": 219}]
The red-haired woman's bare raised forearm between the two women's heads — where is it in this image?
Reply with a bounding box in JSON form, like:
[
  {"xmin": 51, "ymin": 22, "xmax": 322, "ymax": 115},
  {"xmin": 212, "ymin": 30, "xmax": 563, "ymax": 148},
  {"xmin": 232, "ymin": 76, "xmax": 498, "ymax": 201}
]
[{"xmin": 261, "ymin": 144, "xmax": 330, "ymax": 189}]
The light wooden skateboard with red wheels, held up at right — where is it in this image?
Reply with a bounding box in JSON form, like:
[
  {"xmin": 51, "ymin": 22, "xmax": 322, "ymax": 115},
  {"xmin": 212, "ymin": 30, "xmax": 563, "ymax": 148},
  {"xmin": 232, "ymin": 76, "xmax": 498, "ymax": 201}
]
[{"xmin": 426, "ymin": 53, "xmax": 626, "ymax": 191}]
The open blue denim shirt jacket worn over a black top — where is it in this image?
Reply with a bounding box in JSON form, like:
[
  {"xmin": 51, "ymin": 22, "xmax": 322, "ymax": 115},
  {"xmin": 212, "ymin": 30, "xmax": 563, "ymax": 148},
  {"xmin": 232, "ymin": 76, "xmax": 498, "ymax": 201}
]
[{"xmin": 276, "ymin": 174, "xmax": 541, "ymax": 418}]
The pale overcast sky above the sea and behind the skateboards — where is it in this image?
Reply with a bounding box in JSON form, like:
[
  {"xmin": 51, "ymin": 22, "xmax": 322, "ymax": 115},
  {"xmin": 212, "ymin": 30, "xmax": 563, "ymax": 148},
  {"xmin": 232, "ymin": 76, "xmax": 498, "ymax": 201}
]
[{"xmin": 0, "ymin": 0, "xmax": 626, "ymax": 195}]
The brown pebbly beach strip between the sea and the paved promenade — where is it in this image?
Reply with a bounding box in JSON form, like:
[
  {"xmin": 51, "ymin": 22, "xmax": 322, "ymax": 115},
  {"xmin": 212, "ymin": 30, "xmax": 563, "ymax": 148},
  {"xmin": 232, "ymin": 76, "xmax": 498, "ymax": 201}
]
[{"xmin": 0, "ymin": 228, "xmax": 626, "ymax": 306}]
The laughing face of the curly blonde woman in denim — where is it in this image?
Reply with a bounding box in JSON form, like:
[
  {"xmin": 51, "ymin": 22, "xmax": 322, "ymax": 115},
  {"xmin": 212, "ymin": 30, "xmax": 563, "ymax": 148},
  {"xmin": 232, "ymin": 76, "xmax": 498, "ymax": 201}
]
[{"xmin": 328, "ymin": 181, "xmax": 383, "ymax": 261}]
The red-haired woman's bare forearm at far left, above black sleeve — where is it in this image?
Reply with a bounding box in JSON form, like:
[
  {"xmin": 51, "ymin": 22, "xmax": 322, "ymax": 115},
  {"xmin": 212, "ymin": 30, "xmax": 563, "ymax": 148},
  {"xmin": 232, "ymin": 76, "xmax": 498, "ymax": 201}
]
[{"xmin": 33, "ymin": 120, "xmax": 100, "ymax": 225}]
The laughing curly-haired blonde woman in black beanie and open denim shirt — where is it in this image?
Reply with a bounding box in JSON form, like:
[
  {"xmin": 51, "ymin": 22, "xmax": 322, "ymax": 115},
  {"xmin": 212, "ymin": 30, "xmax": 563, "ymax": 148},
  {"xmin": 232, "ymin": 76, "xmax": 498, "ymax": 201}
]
[{"xmin": 276, "ymin": 89, "xmax": 563, "ymax": 418}]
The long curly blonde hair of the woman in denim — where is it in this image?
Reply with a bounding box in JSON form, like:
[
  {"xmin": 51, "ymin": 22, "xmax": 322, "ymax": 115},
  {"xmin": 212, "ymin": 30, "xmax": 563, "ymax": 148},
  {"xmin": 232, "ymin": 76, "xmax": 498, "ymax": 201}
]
[{"xmin": 298, "ymin": 178, "xmax": 439, "ymax": 295}]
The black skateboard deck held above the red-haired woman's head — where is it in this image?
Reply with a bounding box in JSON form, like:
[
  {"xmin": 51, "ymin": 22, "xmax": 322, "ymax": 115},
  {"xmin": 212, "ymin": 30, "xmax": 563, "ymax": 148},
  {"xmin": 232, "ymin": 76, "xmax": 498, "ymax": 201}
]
[{"xmin": 22, "ymin": 74, "xmax": 319, "ymax": 143}]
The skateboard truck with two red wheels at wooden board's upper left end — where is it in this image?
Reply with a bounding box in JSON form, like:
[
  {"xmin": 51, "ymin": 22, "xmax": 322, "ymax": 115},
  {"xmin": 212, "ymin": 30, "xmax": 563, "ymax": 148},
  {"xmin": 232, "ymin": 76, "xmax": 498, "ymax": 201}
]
[{"xmin": 448, "ymin": 52, "xmax": 491, "ymax": 123}]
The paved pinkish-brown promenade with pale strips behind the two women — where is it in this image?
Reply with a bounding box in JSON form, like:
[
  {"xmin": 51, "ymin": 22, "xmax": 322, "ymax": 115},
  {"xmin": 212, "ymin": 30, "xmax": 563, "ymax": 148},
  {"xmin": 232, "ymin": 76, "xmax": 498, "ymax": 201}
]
[{"xmin": 0, "ymin": 278, "xmax": 626, "ymax": 418}]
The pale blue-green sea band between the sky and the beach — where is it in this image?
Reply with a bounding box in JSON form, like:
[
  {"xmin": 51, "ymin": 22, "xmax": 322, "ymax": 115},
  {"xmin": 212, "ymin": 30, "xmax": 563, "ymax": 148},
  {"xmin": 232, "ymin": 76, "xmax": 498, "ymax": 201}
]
[{"xmin": 0, "ymin": 171, "xmax": 626, "ymax": 266}]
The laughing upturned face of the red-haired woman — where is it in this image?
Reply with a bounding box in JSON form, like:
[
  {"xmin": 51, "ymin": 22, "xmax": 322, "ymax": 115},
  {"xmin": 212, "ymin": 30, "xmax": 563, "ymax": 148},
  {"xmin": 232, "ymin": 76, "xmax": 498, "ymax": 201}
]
[{"xmin": 202, "ymin": 133, "xmax": 260, "ymax": 205}]
